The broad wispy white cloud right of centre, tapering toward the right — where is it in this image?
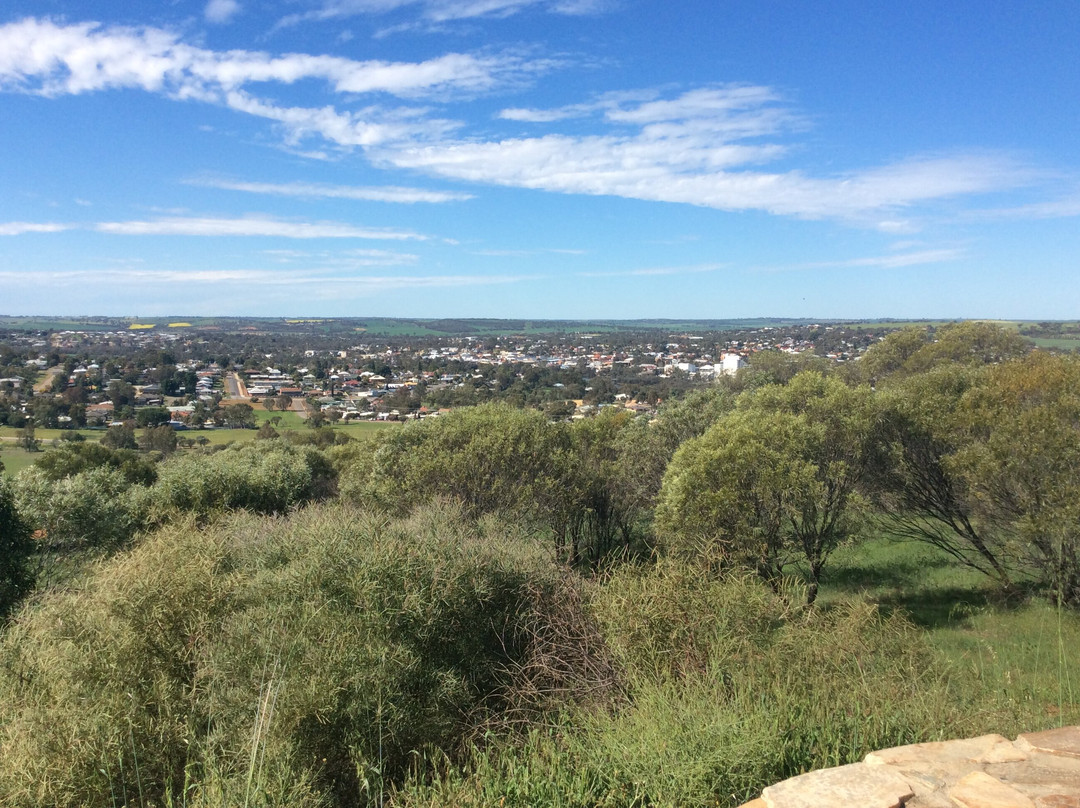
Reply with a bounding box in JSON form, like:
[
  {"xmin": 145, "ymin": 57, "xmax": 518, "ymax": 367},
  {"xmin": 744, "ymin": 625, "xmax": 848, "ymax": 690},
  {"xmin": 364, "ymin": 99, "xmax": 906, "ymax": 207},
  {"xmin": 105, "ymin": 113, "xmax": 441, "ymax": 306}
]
[{"xmin": 390, "ymin": 84, "xmax": 1035, "ymax": 221}]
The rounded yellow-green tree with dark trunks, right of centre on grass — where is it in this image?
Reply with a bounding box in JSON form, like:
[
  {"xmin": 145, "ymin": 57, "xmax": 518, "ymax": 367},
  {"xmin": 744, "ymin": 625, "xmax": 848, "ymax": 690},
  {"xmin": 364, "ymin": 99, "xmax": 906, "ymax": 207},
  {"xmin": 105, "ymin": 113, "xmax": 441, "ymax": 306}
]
[{"xmin": 656, "ymin": 372, "xmax": 874, "ymax": 603}]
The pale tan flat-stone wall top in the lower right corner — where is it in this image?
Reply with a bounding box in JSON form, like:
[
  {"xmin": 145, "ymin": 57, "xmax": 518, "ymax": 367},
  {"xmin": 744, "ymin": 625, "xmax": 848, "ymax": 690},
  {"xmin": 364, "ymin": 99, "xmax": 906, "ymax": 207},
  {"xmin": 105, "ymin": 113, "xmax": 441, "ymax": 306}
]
[{"xmin": 743, "ymin": 727, "xmax": 1080, "ymax": 808}]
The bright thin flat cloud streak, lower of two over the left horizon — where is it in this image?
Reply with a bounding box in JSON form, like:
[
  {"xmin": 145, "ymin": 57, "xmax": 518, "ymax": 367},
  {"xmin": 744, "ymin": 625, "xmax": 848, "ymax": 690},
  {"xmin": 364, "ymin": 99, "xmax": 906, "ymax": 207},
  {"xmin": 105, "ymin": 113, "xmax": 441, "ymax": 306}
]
[{"xmin": 95, "ymin": 216, "xmax": 428, "ymax": 241}]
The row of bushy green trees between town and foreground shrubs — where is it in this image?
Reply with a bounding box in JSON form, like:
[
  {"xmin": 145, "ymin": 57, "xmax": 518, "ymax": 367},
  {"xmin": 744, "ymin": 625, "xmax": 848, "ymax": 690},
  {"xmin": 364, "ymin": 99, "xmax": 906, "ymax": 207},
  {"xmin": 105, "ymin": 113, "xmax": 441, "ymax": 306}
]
[{"xmin": 2, "ymin": 323, "xmax": 1080, "ymax": 605}]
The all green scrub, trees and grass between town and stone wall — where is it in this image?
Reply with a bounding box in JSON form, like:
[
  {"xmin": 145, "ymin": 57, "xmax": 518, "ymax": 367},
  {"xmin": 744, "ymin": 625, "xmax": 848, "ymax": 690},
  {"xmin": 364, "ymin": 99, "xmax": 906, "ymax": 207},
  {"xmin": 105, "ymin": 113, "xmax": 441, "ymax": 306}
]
[{"xmin": 0, "ymin": 323, "xmax": 1080, "ymax": 808}]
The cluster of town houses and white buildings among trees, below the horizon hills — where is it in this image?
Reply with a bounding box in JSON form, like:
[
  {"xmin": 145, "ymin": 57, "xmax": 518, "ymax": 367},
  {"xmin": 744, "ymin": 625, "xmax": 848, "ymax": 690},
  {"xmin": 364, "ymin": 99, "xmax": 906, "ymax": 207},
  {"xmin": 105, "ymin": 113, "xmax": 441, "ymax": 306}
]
[{"xmin": 0, "ymin": 325, "xmax": 877, "ymax": 426}]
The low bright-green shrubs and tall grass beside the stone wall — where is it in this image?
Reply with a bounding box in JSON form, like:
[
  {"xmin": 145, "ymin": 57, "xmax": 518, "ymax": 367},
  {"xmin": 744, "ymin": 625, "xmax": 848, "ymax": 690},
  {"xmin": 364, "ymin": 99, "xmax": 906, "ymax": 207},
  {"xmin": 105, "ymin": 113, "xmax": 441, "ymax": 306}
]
[{"xmin": 397, "ymin": 564, "xmax": 976, "ymax": 806}]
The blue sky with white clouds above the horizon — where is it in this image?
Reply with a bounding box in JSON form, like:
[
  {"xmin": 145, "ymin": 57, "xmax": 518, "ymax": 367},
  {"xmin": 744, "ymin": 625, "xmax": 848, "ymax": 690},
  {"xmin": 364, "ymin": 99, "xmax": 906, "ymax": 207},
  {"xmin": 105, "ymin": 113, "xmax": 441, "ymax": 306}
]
[{"xmin": 0, "ymin": 0, "xmax": 1080, "ymax": 319}]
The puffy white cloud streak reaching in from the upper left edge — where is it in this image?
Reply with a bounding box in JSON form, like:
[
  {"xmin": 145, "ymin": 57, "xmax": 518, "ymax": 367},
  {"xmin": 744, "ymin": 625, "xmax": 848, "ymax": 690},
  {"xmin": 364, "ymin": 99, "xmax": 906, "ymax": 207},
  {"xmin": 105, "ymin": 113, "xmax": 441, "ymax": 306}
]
[{"xmin": 0, "ymin": 18, "xmax": 550, "ymax": 146}]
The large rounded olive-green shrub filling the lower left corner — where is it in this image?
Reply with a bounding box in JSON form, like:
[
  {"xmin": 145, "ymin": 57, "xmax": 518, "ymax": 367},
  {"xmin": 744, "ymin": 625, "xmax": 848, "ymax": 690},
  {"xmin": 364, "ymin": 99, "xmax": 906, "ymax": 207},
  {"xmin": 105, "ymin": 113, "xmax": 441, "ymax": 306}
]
[{"xmin": 0, "ymin": 507, "xmax": 570, "ymax": 808}]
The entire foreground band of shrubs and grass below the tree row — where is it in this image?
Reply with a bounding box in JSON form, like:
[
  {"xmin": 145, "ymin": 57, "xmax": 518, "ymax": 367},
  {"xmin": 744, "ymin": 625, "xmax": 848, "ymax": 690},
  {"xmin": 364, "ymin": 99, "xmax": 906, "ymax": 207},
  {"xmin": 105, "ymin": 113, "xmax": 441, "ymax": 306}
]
[{"xmin": 0, "ymin": 503, "xmax": 1080, "ymax": 808}]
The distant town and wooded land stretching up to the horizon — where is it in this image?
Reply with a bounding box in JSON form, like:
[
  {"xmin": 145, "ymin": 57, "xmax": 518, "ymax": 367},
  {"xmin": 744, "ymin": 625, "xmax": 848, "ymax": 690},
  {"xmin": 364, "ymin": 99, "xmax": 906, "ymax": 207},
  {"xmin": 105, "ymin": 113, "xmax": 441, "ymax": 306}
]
[{"xmin": 0, "ymin": 318, "xmax": 1072, "ymax": 430}]
